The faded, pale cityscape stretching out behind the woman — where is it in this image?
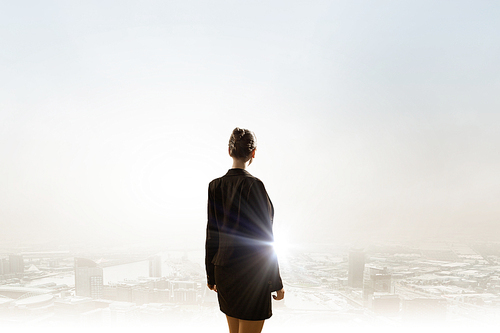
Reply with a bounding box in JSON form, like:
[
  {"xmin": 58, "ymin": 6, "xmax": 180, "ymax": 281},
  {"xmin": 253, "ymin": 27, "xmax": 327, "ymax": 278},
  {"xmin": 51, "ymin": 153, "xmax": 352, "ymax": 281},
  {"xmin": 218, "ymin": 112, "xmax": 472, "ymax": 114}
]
[{"xmin": 0, "ymin": 236, "xmax": 500, "ymax": 332}]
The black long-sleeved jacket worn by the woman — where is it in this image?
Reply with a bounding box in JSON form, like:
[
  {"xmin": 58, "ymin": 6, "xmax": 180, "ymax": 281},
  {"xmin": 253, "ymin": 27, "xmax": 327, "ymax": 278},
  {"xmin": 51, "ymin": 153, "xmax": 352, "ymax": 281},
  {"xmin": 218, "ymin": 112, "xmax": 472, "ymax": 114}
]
[{"xmin": 205, "ymin": 169, "xmax": 283, "ymax": 291}]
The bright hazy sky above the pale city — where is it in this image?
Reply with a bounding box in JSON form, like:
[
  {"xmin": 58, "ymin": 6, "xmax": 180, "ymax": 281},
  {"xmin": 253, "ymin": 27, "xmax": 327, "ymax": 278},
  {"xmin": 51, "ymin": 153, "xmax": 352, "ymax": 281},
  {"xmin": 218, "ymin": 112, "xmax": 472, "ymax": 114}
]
[{"xmin": 0, "ymin": 0, "xmax": 500, "ymax": 247}]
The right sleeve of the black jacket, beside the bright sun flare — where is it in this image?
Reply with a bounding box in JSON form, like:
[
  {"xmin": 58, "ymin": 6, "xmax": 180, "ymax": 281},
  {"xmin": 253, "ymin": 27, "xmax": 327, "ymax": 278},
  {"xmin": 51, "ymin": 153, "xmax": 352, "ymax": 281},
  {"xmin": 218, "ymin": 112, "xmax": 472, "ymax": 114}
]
[{"xmin": 250, "ymin": 180, "xmax": 283, "ymax": 291}]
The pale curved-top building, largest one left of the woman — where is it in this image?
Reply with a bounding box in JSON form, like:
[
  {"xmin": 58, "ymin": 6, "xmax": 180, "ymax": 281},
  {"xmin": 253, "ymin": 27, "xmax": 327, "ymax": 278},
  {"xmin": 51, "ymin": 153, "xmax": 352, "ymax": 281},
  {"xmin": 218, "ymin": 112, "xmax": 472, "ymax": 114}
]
[{"xmin": 75, "ymin": 258, "xmax": 103, "ymax": 298}]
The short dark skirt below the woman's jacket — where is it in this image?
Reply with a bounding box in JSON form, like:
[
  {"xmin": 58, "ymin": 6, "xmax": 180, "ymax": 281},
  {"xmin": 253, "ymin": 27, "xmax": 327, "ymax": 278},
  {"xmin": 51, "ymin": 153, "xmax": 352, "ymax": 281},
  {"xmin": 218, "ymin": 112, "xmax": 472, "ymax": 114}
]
[{"xmin": 215, "ymin": 263, "xmax": 272, "ymax": 320}]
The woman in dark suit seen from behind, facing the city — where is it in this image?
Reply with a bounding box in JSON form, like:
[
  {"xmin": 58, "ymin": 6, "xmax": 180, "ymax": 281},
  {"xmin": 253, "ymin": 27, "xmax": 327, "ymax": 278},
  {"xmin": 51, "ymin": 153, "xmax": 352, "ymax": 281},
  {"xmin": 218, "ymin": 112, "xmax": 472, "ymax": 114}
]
[{"xmin": 205, "ymin": 127, "xmax": 285, "ymax": 333}]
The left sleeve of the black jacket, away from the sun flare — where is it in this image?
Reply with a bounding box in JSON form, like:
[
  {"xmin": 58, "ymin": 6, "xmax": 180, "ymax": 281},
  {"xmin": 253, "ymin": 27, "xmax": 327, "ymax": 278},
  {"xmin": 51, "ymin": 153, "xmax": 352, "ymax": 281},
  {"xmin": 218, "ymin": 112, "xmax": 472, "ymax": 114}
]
[{"xmin": 205, "ymin": 183, "xmax": 219, "ymax": 285}]
